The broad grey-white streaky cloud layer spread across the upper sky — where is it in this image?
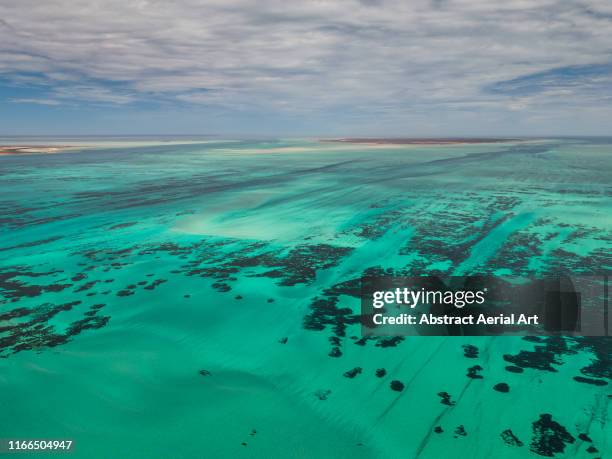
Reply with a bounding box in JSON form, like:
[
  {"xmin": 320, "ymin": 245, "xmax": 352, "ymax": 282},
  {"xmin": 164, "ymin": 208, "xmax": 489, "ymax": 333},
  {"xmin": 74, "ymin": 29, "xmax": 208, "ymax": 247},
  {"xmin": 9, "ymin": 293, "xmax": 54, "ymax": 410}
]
[{"xmin": 0, "ymin": 0, "xmax": 612, "ymax": 133}]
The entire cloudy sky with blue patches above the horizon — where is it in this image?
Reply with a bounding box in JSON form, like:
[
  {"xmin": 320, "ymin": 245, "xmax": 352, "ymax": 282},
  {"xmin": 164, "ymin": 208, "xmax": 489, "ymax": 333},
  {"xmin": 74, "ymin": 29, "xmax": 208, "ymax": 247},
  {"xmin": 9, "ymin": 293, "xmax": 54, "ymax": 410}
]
[{"xmin": 0, "ymin": 0, "xmax": 612, "ymax": 136}]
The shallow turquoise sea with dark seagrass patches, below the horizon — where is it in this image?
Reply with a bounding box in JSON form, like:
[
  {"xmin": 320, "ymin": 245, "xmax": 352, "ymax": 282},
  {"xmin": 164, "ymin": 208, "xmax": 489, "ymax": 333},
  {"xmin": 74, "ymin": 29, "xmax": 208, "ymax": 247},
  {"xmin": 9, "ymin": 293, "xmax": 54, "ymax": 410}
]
[{"xmin": 0, "ymin": 139, "xmax": 612, "ymax": 458}]
